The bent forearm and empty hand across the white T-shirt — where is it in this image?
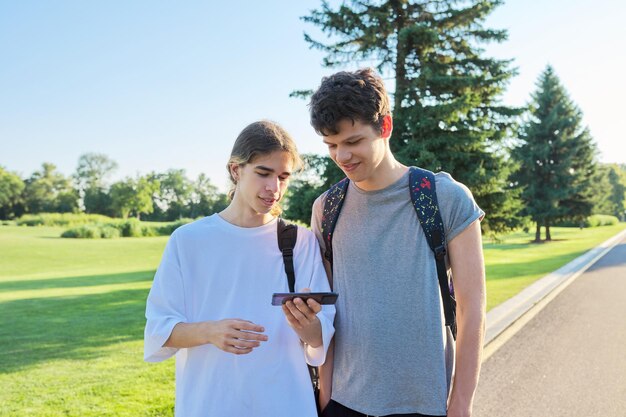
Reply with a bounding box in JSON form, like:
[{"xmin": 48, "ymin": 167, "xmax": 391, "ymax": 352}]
[{"xmin": 163, "ymin": 319, "xmax": 267, "ymax": 355}]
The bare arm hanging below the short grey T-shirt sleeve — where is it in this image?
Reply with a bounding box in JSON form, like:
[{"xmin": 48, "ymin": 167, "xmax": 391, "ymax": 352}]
[{"xmin": 448, "ymin": 221, "xmax": 486, "ymax": 417}]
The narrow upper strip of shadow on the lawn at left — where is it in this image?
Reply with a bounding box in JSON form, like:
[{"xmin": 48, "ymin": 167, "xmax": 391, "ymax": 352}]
[{"xmin": 0, "ymin": 271, "xmax": 155, "ymax": 291}]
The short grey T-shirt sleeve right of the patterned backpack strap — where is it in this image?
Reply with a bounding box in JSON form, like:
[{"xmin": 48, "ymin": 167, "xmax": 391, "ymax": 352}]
[{"xmin": 436, "ymin": 173, "xmax": 485, "ymax": 242}]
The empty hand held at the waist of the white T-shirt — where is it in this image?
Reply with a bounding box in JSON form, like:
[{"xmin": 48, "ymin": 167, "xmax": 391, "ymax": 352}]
[{"xmin": 206, "ymin": 319, "xmax": 267, "ymax": 355}]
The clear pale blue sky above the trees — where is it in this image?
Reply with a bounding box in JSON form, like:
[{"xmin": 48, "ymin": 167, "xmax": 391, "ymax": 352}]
[{"xmin": 0, "ymin": 0, "xmax": 626, "ymax": 190}]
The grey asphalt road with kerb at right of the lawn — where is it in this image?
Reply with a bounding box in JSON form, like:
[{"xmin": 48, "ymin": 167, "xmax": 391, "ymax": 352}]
[{"xmin": 474, "ymin": 238, "xmax": 626, "ymax": 417}]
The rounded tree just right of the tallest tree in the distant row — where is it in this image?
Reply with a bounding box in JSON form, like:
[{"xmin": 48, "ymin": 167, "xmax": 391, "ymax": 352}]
[{"xmin": 110, "ymin": 177, "xmax": 159, "ymax": 220}]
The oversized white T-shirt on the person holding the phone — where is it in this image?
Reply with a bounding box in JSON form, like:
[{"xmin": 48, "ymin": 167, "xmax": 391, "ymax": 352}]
[{"xmin": 144, "ymin": 214, "xmax": 335, "ymax": 417}]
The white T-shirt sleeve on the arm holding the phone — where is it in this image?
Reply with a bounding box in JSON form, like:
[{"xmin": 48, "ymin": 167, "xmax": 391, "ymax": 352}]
[{"xmin": 294, "ymin": 227, "xmax": 335, "ymax": 366}]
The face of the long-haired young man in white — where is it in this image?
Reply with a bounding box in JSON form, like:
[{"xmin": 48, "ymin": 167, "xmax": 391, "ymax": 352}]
[{"xmin": 231, "ymin": 151, "xmax": 293, "ymax": 215}]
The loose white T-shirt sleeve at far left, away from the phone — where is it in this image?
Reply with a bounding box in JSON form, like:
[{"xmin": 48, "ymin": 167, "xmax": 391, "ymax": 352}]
[{"xmin": 144, "ymin": 233, "xmax": 187, "ymax": 362}]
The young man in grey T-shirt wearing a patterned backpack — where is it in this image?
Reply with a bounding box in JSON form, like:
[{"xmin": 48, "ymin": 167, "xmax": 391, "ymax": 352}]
[{"xmin": 310, "ymin": 69, "xmax": 485, "ymax": 417}]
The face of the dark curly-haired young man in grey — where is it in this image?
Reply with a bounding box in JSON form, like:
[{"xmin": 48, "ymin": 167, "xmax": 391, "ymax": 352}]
[{"xmin": 324, "ymin": 119, "xmax": 389, "ymax": 183}]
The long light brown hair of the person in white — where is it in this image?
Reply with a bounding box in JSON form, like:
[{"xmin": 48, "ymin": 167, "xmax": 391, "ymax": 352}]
[{"xmin": 226, "ymin": 120, "xmax": 303, "ymax": 216}]
